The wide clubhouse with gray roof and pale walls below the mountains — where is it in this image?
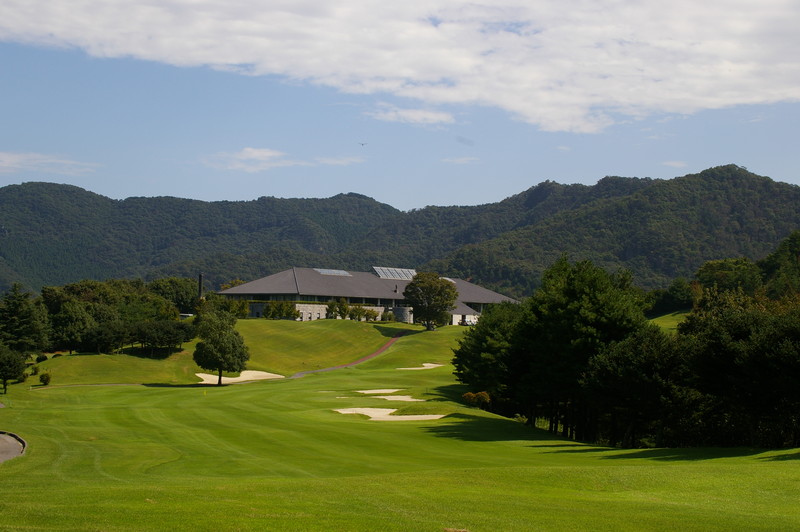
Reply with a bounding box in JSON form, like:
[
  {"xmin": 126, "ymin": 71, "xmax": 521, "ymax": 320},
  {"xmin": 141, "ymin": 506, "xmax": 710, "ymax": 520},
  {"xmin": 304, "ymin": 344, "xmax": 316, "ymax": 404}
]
[{"xmin": 219, "ymin": 266, "xmax": 514, "ymax": 325}]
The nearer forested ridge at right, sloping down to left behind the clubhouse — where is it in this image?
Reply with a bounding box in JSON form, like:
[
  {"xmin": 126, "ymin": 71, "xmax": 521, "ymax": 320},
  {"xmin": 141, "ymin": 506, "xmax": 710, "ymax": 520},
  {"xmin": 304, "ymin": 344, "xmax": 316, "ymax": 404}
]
[{"xmin": 424, "ymin": 165, "xmax": 800, "ymax": 295}]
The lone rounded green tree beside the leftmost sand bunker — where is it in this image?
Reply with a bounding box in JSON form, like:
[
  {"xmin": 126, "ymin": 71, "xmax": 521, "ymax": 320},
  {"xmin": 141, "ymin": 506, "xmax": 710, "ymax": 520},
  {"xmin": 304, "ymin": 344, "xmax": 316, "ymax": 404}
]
[{"xmin": 193, "ymin": 312, "xmax": 250, "ymax": 386}]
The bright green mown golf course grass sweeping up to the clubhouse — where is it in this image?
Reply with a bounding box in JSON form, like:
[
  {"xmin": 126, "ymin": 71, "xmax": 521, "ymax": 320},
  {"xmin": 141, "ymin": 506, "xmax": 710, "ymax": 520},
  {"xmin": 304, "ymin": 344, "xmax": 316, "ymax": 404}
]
[{"xmin": 0, "ymin": 320, "xmax": 800, "ymax": 532}]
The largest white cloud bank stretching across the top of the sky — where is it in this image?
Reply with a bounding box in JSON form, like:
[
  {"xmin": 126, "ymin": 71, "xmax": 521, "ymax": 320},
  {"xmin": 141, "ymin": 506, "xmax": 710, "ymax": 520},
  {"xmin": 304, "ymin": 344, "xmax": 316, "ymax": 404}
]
[{"xmin": 0, "ymin": 0, "xmax": 800, "ymax": 132}]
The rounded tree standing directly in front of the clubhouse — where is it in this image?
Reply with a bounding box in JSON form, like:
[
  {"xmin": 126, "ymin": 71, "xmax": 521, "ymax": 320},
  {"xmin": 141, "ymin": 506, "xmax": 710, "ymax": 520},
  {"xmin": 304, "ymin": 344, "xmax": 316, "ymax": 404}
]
[{"xmin": 403, "ymin": 272, "xmax": 458, "ymax": 331}]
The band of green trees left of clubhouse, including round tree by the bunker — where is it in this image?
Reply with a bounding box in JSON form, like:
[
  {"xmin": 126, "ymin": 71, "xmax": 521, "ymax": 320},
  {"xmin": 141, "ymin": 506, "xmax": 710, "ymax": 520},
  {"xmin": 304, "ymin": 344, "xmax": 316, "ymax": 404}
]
[{"xmin": 0, "ymin": 277, "xmax": 255, "ymax": 391}]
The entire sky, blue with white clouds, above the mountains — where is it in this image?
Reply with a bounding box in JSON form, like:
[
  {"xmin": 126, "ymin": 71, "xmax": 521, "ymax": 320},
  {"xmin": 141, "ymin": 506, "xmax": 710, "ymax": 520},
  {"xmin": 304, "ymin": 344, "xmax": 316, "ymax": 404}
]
[{"xmin": 0, "ymin": 0, "xmax": 800, "ymax": 210}]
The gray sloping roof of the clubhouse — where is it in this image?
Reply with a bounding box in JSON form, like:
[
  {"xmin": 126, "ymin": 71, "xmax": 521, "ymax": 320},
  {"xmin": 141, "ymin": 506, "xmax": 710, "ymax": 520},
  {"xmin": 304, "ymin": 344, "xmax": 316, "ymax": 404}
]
[{"xmin": 220, "ymin": 268, "xmax": 513, "ymax": 305}]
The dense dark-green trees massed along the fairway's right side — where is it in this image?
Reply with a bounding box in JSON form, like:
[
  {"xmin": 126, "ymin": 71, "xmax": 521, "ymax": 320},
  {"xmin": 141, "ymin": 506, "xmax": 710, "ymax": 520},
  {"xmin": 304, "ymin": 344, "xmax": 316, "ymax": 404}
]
[{"xmin": 453, "ymin": 232, "xmax": 800, "ymax": 447}]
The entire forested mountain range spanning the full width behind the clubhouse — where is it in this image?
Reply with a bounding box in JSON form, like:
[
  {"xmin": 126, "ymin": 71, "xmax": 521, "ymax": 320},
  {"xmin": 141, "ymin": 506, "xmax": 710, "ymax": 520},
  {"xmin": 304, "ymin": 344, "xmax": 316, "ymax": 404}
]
[{"xmin": 0, "ymin": 165, "xmax": 800, "ymax": 296}]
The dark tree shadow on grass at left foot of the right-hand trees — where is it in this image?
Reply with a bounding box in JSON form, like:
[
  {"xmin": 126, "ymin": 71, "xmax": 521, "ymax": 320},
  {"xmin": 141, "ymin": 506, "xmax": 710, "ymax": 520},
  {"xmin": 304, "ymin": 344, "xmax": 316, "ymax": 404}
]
[{"xmin": 422, "ymin": 414, "xmax": 556, "ymax": 441}]
